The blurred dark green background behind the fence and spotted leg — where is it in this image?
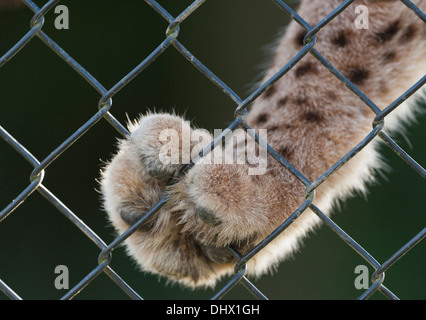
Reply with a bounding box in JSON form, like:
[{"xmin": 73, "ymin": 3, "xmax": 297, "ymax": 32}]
[{"xmin": 0, "ymin": 0, "xmax": 426, "ymax": 299}]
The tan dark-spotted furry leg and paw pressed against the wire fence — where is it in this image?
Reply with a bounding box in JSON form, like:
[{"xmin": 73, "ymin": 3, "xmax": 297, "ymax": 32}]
[{"xmin": 101, "ymin": 0, "xmax": 426, "ymax": 287}]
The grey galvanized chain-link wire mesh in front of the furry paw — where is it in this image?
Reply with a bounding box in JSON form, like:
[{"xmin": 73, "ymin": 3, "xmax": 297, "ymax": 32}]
[{"xmin": 0, "ymin": 0, "xmax": 426, "ymax": 299}]
